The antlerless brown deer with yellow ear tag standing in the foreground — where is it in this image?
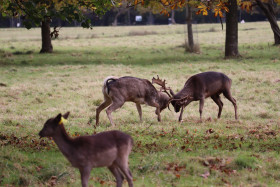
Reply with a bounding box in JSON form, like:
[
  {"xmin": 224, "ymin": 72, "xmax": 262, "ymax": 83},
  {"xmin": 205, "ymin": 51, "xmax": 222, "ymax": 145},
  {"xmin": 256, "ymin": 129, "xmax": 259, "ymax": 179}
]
[{"xmin": 39, "ymin": 112, "xmax": 133, "ymax": 187}]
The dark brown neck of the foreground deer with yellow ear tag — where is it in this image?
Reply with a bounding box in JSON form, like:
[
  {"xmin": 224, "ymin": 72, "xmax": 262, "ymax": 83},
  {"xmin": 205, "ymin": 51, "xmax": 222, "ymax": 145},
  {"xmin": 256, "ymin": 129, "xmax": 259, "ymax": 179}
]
[{"xmin": 53, "ymin": 125, "xmax": 74, "ymax": 157}]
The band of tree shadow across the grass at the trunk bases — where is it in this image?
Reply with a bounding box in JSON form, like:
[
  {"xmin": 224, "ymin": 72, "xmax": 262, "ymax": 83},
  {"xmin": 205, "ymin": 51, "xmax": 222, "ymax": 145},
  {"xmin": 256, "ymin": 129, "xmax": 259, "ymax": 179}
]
[{"xmin": 0, "ymin": 45, "xmax": 279, "ymax": 66}]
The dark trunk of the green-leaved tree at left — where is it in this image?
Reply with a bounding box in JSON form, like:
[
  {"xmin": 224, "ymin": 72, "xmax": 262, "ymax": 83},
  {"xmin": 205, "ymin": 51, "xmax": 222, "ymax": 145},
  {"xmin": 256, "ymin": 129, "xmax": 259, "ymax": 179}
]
[{"xmin": 40, "ymin": 18, "xmax": 53, "ymax": 53}]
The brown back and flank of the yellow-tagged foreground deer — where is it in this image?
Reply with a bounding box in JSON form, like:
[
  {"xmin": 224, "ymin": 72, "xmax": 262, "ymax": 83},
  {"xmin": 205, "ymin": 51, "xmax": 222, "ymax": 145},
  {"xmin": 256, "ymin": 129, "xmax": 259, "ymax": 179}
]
[{"xmin": 69, "ymin": 131, "xmax": 133, "ymax": 167}]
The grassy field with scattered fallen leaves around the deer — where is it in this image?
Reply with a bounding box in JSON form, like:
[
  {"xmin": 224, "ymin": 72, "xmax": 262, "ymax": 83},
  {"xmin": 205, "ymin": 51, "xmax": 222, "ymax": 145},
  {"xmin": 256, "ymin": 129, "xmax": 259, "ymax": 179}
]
[{"xmin": 0, "ymin": 22, "xmax": 280, "ymax": 187}]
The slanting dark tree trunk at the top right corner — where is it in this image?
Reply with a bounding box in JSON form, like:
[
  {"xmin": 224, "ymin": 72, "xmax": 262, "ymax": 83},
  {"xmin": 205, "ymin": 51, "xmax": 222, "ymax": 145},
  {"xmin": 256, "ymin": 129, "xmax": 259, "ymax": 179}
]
[{"xmin": 256, "ymin": 0, "xmax": 280, "ymax": 45}]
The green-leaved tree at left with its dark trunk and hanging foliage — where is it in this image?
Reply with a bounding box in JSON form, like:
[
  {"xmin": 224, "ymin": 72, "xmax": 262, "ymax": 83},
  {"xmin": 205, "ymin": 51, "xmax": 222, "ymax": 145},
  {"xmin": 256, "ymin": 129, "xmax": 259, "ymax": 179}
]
[{"xmin": 0, "ymin": 0, "xmax": 113, "ymax": 53}]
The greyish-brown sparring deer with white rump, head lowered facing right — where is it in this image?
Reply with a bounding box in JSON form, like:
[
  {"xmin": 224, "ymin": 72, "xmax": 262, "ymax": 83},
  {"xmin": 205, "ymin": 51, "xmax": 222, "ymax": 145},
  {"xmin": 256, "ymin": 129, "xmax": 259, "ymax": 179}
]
[{"xmin": 96, "ymin": 76, "xmax": 170, "ymax": 126}]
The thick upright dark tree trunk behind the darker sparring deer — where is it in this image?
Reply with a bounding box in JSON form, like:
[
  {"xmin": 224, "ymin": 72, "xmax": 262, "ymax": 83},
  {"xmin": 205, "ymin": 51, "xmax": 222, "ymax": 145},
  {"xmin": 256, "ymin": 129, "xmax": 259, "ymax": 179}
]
[{"xmin": 225, "ymin": 0, "xmax": 239, "ymax": 57}]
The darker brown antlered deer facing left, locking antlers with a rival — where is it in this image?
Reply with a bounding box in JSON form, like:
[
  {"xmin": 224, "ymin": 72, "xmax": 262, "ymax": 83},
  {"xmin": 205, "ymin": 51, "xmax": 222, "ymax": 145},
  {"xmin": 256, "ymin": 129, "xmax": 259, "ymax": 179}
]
[{"xmin": 153, "ymin": 71, "xmax": 238, "ymax": 122}]
